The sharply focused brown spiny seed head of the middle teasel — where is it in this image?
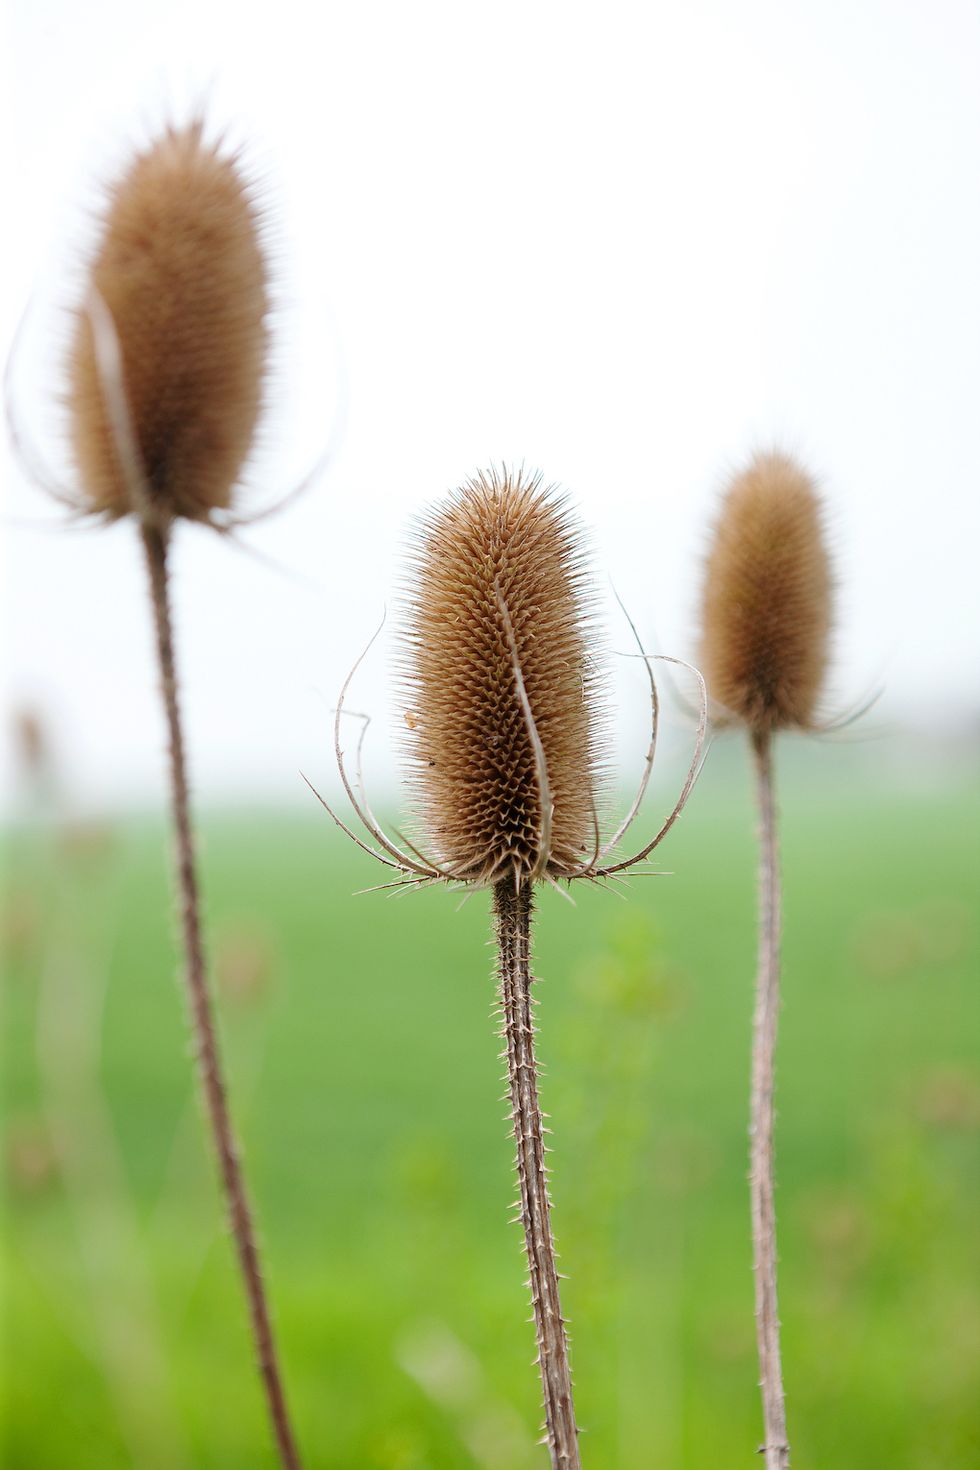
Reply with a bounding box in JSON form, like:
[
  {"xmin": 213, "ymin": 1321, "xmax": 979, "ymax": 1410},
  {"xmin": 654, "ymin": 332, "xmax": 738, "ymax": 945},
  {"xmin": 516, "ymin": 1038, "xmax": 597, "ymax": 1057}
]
[{"xmin": 400, "ymin": 469, "xmax": 602, "ymax": 886}]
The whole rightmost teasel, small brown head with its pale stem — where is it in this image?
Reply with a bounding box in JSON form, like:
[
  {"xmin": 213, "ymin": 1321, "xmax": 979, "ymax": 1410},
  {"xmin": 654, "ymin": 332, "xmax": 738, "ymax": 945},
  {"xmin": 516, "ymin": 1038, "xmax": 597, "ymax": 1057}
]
[{"xmin": 701, "ymin": 453, "xmax": 833, "ymax": 1470}]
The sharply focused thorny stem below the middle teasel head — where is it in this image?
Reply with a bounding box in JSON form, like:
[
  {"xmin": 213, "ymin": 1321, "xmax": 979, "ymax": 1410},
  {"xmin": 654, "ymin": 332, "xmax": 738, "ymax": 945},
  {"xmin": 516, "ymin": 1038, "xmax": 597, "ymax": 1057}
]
[{"xmin": 494, "ymin": 882, "xmax": 582, "ymax": 1470}]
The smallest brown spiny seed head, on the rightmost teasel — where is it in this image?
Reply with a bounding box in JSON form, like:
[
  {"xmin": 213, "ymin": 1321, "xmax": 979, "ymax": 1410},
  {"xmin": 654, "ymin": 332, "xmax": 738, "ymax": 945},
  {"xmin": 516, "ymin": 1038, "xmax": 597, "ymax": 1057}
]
[{"xmin": 701, "ymin": 453, "xmax": 833, "ymax": 735}]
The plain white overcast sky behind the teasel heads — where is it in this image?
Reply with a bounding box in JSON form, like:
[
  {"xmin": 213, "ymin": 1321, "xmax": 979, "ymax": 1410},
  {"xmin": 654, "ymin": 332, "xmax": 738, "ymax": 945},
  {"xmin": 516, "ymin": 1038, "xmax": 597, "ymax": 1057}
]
[{"xmin": 0, "ymin": 0, "xmax": 980, "ymax": 803}]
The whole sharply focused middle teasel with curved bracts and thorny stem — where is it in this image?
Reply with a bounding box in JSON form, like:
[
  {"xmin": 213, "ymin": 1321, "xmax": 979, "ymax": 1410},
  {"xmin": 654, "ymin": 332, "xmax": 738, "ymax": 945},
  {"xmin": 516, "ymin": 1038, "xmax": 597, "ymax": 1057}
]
[{"xmin": 317, "ymin": 469, "xmax": 707, "ymax": 1470}]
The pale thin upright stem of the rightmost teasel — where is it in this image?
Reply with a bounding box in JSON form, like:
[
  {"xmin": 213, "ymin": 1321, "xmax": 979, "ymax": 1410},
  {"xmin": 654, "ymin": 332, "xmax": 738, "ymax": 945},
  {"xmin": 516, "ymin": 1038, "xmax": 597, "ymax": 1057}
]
[{"xmin": 749, "ymin": 734, "xmax": 789, "ymax": 1470}]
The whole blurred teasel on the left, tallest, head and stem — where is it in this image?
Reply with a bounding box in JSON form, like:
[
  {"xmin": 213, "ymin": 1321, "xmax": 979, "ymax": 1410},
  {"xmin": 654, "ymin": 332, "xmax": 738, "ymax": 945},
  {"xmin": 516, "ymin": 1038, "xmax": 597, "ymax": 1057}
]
[{"xmin": 68, "ymin": 121, "xmax": 300, "ymax": 1470}]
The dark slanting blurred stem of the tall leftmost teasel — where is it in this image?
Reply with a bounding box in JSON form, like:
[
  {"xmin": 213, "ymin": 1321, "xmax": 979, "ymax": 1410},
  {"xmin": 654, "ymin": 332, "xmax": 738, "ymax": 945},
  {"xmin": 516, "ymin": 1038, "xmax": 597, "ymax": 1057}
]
[{"xmin": 143, "ymin": 525, "xmax": 300, "ymax": 1470}]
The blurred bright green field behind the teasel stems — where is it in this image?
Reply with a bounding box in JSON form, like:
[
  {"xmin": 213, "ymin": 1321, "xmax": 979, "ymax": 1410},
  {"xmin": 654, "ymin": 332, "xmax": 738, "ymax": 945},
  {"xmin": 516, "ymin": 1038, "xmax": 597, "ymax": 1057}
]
[{"xmin": 1, "ymin": 747, "xmax": 980, "ymax": 1470}]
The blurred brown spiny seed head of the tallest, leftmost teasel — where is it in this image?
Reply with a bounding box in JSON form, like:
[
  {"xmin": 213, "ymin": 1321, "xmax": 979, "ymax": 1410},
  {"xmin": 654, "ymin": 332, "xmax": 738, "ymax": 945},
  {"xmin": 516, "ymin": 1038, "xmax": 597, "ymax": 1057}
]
[{"xmin": 68, "ymin": 121, "xmax": 269, "ymax": 520}]
